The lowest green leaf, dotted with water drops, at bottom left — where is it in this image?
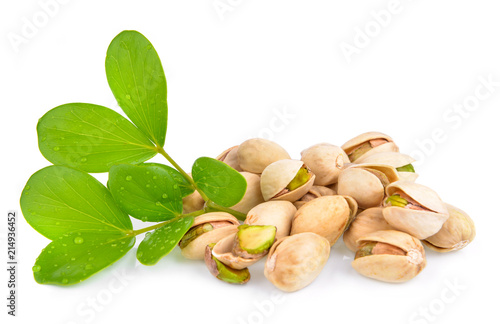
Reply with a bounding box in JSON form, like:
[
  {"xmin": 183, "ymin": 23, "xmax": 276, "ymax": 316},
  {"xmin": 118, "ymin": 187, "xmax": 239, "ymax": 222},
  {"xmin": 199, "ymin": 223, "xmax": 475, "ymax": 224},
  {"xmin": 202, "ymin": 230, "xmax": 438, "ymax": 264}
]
[{"xmin": 33, "ymin": 232, "xmax": 135, "ymax": 286}]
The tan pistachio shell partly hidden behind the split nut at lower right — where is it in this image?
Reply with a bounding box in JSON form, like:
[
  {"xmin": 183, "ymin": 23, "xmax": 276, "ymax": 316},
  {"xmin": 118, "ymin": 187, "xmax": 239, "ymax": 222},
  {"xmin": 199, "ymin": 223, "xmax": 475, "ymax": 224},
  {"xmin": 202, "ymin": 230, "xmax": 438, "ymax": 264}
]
[{"xmin": 343, "ymin": 207, "xmax": 395, "ymax": 252}]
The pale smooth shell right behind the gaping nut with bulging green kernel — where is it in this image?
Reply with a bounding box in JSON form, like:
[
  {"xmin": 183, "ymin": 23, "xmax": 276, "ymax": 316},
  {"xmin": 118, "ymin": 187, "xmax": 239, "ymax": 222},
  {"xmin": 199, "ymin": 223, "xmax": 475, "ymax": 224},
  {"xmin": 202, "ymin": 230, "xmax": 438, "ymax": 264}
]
[{"xmin": 244, "ymin": 200, "xmax": 297, "ymax": 240}]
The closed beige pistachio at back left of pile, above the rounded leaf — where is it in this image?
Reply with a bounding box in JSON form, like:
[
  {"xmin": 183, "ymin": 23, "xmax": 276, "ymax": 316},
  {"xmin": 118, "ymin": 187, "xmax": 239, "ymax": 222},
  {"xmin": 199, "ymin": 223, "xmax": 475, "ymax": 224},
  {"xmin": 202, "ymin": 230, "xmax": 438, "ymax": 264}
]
[{"xmin": 237, "ymin": 138, "xmax": 290, "ymax": 173}]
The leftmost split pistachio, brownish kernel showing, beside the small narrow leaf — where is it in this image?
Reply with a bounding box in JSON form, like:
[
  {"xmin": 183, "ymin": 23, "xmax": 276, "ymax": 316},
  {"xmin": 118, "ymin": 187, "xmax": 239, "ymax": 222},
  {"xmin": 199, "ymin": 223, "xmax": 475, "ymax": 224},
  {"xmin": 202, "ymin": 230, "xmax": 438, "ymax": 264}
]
[{"xmin": 179, "ymin": 212, "xmax": 240, "ymax": 260}]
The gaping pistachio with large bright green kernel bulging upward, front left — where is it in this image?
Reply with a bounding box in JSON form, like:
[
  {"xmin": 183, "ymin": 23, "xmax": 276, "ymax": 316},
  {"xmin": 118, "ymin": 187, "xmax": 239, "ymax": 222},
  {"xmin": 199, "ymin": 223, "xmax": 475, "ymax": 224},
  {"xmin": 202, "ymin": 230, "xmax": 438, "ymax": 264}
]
[{"xmin": 212, "ymin": 225, "xmax": 276, "ymax": 270}]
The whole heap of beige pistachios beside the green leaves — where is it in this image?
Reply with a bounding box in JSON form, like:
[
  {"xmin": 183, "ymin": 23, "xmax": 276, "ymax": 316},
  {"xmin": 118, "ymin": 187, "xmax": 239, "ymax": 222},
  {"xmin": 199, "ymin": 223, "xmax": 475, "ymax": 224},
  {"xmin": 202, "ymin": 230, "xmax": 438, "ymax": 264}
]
[{"xmin": 179, "ymin": 132, "xmax": 475, "ymax": 292}]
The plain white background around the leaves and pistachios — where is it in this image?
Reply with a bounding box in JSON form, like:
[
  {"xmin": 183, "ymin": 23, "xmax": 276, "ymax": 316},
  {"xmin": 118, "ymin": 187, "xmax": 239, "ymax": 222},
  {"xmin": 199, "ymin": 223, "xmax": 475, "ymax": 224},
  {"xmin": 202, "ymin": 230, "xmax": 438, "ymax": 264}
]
[{"xmin": 0, "ymin": 0, "xmax": 500, "ymax": 324}]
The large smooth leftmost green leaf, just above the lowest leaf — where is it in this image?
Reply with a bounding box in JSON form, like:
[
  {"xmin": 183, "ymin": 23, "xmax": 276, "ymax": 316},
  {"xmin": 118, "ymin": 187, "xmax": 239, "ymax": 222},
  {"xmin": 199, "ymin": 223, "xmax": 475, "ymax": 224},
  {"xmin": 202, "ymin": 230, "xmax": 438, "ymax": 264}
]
[{"xmin": 21, "ymin": 166, "xmax": 132, "ymax": 239}]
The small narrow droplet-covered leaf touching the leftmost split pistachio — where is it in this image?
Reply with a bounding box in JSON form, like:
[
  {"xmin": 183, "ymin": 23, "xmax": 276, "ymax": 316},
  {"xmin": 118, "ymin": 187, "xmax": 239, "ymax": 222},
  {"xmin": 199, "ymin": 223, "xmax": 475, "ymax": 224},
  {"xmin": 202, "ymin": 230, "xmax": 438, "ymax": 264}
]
[{"xmin": 137, "ymin": 216, "xmax": 194, "ymax": 265}]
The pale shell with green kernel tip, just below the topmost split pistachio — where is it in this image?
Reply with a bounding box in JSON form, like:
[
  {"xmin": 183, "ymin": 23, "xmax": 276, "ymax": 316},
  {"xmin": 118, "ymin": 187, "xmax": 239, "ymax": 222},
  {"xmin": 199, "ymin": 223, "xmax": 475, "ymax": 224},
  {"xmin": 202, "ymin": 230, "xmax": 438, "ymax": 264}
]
[{"xmin": 356, "ymin": 152, "xmax": 418, "ymax": 181}]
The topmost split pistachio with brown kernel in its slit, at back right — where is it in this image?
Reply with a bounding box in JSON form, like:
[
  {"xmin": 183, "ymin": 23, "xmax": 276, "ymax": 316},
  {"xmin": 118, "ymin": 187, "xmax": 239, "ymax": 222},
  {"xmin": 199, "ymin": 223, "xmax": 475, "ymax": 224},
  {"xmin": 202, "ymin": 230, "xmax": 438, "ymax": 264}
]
[{"xmin": 342, "ymin": 132, "xmax": 399, "ymax": 162}]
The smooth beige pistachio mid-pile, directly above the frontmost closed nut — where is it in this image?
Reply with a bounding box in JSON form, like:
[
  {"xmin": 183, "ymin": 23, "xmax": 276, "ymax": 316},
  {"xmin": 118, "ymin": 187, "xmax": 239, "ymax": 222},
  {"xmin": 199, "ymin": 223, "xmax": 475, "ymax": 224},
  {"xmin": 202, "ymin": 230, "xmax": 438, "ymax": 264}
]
[{"xmin": 290, "ymin": 195, "xmax": 357, "ymax": 246}]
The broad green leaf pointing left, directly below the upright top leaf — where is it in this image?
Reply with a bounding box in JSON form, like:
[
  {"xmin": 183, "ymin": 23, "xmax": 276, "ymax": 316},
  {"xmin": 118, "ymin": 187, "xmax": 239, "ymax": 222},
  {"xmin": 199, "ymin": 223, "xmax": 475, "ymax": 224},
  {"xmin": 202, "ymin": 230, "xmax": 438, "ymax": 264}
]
[{"xmin": 37, "ymin": 103, "xmax": 157, "ymax": 172}]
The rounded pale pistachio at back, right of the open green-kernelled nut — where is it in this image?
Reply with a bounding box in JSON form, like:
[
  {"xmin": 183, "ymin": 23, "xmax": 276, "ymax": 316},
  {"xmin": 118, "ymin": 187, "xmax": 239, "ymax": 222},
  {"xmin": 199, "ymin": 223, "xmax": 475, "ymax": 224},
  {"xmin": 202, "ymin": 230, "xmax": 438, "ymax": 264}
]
[{"xmin": 301, "ymin": 143, "xmax": 349, "ymax": 186}]
